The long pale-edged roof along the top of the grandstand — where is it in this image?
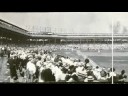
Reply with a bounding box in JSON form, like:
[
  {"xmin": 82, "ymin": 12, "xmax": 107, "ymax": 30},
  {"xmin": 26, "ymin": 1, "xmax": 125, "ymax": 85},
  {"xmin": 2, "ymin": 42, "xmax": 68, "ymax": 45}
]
[{"xmin": 0, "ymin": 19, "xmax": 128, "ymax": 39}]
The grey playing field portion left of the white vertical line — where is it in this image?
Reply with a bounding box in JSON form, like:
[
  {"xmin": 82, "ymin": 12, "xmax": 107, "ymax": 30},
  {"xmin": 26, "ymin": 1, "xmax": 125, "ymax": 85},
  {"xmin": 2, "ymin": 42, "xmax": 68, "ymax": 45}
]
[{"xmin": 55, "ymin": 50, "xmax": 112, "ymax": 68}]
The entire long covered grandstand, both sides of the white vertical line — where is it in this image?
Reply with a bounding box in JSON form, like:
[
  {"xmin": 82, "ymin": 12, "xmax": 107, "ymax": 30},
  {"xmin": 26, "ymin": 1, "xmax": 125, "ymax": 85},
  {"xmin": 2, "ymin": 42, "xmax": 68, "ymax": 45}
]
[{"xmin": 0, "ymin": 20, "xmax": 128, "ymax": 44}]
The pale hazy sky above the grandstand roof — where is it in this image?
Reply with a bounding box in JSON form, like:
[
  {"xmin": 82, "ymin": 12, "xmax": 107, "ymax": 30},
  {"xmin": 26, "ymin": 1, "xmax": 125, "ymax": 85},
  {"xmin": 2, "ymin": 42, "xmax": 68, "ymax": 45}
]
[{"xmin": 0, "ymin": 12, "xmax": 128, "ymax": 34}]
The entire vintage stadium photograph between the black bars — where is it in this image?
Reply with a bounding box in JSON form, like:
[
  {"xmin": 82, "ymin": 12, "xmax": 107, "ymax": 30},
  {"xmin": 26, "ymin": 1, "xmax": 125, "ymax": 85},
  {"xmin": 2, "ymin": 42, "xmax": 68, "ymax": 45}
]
[{"xmin": 0, "ymin": 12, "xmax": 125, "ymax": 84}]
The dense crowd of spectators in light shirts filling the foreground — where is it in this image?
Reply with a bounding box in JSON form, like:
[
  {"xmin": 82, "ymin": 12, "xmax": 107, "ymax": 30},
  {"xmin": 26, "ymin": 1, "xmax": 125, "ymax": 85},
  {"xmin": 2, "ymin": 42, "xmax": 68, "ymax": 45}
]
[{"xmin": 1, "ymin": 44, "xmax": 127, "ymax": 83}]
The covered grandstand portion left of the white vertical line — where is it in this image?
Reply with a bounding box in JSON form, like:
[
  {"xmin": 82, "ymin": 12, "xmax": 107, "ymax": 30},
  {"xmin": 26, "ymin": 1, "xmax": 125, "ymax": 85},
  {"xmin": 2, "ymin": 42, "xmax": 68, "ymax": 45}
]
[{"xmin": 0, "ymin": 20, "xmax": 111, "ymax": 43}]
